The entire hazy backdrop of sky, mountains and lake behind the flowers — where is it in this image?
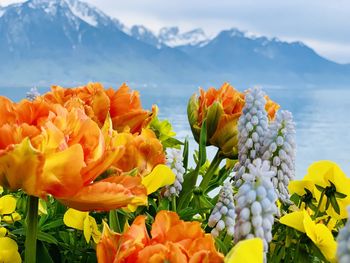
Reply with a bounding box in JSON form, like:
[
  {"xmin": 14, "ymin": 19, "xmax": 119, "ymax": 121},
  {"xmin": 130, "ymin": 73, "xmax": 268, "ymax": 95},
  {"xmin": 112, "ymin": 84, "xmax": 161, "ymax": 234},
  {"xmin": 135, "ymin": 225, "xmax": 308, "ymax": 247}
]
[{"xmin": 0, "ymin": 0, "xmax": 350, "ymax": 178}]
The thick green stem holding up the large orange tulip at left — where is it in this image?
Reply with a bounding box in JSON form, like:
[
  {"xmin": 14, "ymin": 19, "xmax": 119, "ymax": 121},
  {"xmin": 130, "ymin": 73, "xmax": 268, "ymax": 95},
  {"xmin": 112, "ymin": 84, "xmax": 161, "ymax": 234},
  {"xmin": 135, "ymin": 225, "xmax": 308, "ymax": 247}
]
[{"xmin": 24, "ymin": 196, "xmax": 39, "ymax": 263}]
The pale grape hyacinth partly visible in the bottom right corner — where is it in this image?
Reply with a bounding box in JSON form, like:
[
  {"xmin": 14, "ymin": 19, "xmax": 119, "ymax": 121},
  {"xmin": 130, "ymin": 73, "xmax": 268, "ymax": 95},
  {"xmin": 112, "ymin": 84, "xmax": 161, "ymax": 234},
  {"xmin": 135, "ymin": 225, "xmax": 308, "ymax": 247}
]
[{"xmin": 337, "ymin": 206, "xmax": 350, "ymax": 263}]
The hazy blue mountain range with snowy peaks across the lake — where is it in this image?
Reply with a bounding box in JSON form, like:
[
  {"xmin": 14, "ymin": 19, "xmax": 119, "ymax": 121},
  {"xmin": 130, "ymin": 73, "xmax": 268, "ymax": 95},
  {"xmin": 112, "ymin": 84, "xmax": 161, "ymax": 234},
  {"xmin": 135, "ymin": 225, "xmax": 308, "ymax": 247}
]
[{"xmin": 0, "ymin": 0, "xmax": 350, "ymax": 86}]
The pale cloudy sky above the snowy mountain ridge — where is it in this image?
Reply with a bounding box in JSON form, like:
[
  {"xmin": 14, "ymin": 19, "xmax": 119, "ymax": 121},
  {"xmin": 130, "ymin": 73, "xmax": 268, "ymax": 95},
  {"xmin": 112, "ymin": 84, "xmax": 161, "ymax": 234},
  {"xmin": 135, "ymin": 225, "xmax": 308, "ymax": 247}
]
[{"xmin": 0, "ymin": 0, "xmax": 350, "ymax": 63}]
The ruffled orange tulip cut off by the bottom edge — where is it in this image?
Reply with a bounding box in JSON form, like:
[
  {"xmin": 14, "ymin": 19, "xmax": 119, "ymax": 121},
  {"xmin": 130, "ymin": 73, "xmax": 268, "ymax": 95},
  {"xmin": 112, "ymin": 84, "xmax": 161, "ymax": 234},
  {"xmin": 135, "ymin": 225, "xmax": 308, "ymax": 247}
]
[{"xmin": 97, "ymin": 211, "xmax": 224, "ymax": 263}]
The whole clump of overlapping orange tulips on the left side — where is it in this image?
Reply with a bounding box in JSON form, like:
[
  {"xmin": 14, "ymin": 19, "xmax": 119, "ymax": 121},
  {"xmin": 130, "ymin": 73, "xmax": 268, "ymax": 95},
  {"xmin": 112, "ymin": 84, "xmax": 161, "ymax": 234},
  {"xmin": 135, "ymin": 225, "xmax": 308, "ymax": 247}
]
[{"xmin": 0, "ymin": 84, "xmax": 165, "ymax": 211}]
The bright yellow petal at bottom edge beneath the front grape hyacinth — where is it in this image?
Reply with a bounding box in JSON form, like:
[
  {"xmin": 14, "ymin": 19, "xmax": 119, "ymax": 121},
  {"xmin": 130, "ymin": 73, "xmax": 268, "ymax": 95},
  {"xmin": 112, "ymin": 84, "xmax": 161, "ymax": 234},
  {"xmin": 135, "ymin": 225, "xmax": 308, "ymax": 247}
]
[{"xmin": 225, "ymin": 238, "xmax": 264, "ymax": 263}]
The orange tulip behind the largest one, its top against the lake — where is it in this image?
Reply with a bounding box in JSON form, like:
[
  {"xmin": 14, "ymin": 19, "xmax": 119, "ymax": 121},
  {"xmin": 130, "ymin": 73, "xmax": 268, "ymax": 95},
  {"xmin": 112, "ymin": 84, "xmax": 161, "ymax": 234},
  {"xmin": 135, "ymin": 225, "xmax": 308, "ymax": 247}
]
[{"xmin": 43, "ymin": 83, "xmax": 156, "ymax": 133}]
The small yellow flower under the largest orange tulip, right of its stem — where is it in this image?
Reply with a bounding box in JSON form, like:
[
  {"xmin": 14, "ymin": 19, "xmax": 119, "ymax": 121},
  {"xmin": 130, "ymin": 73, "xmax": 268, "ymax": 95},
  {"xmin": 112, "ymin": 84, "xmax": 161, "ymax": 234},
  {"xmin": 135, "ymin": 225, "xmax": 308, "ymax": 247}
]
[{"xmin": 63, "ymin": 208, "xmax": 101, "ymax": 244}]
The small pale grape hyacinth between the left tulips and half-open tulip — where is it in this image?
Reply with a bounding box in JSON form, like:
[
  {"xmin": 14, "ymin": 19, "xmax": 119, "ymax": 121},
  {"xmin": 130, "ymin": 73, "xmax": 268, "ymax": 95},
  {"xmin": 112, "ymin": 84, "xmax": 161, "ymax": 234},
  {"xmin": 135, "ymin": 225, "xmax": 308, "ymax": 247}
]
[{"xmin": 164, "ymin": 149, "xmax": 185, "ymax": 199}]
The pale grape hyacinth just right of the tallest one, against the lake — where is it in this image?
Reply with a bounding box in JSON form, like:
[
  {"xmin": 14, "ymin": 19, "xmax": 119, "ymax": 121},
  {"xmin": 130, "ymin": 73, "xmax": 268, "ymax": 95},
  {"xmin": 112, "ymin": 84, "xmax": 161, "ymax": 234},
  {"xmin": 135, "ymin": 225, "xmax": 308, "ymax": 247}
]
[{"xmin": 262, "ymin": 111, "xmax": 296, "ymax": 204}]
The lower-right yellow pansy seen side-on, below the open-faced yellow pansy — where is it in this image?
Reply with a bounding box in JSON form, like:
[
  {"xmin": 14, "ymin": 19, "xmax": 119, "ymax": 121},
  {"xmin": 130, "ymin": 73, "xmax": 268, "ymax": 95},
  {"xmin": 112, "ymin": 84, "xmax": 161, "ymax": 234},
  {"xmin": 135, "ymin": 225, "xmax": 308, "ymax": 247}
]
[{"xmin": 280, "ymin": 210, "xmax": 337, "ymax": 262}]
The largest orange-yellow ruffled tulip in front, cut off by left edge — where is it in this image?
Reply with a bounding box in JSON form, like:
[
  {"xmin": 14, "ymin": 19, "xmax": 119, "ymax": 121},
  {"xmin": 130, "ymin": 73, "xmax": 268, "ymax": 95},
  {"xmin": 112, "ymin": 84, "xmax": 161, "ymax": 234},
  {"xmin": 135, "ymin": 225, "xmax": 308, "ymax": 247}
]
[{"xmin": 0, "ymin": 98, "xmax": 147, "ymax": 211}]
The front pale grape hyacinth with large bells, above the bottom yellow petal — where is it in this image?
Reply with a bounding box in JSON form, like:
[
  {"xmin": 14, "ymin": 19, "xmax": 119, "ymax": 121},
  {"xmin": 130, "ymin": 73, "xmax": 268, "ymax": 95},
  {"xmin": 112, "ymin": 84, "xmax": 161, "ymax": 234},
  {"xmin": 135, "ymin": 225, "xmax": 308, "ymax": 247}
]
[{"xmin": 235, "ymin": 158, "xmax": 277, "ymax": 252}]
